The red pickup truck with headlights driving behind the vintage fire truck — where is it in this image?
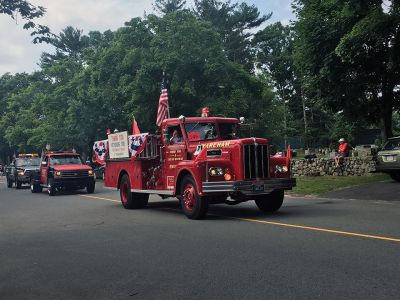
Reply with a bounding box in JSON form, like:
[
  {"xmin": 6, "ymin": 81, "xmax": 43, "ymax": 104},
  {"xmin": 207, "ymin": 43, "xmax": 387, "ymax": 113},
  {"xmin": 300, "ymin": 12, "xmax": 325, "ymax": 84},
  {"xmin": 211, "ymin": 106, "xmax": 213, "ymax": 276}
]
[{"xmin": 31, "ymin": 151, "xmax": 96, "ymax": 196}]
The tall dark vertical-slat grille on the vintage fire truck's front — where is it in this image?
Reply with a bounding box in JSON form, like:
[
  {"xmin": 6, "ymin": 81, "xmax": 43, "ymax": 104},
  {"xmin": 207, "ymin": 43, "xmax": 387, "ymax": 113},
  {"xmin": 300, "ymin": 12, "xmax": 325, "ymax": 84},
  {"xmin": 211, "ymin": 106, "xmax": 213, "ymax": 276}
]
[{"xmin": 243, "ymin": 144, "xmax": 269, "ymax": 179}]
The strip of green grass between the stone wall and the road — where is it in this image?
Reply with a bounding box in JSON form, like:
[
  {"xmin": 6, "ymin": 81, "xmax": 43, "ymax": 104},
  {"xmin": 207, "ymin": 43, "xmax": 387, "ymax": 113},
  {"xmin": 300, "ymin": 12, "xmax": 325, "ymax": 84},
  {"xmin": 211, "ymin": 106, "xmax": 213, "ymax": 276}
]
[{"xmin": 289, "ymin": 174, "xmax": 390, "ymax": 196}]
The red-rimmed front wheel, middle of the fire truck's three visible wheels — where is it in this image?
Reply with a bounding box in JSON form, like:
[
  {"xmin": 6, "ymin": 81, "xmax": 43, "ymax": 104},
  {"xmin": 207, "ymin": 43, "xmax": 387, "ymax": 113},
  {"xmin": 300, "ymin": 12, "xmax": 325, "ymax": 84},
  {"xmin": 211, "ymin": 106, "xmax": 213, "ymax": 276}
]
[{"xmin": 179, "ymin": 175, "xmax": 208, "ymax": 220}]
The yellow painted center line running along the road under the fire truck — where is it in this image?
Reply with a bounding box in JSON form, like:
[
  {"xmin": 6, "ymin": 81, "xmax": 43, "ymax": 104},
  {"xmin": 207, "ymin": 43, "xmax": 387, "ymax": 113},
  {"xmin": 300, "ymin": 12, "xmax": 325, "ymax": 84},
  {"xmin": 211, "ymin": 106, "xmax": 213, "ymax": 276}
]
[{"xmin": 80, "ymin": 195, "xmax": 400, "ymax": 243}]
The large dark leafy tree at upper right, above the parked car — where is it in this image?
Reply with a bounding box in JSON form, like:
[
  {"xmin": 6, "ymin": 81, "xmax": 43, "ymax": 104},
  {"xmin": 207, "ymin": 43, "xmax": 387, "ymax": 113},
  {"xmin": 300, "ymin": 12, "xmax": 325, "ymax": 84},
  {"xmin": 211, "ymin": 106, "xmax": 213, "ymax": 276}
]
[{"xmin": 294, "ymin": 0, "xmax": 400, "ymax": 140}]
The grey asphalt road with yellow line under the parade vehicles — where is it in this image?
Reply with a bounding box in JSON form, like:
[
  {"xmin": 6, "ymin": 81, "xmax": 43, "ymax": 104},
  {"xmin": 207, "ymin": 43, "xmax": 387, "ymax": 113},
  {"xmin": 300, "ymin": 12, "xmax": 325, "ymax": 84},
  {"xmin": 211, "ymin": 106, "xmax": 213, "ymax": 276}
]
[{"xmin": 0, "ymin": 179, "xmax": 400, "ymax": 299}]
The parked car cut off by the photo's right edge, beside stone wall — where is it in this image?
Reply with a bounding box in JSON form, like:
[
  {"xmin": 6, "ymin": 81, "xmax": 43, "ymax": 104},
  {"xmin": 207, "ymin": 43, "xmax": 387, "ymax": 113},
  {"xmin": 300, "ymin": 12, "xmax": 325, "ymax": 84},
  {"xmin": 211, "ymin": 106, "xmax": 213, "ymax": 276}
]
[{"xmin": 376, "ymin": 136, "xmax": 400, "ymax": 182}]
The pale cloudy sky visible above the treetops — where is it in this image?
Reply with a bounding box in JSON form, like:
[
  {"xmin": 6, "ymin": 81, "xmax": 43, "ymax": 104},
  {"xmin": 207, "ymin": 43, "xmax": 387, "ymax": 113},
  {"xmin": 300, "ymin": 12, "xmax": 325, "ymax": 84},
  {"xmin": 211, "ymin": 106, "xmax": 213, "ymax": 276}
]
[{"xmin": 0, "ymin": 0, "xmax": 294, "ymax": 76}]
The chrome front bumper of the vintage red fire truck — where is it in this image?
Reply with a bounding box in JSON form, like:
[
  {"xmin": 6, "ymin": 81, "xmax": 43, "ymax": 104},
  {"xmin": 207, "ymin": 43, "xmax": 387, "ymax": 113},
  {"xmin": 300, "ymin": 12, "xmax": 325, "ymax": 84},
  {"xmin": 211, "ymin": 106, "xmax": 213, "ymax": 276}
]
[{"xmin": 202, "ymin": 178, "xmax": 296, "ymax": 195}]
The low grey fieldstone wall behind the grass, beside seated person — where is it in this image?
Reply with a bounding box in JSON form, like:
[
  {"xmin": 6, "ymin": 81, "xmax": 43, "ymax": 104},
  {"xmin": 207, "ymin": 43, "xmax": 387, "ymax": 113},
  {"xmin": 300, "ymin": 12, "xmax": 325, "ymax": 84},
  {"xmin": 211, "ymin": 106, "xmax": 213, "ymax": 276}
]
[{"xmin": 292, "ymin": 157, "xmax": 375, "ymax": 176}]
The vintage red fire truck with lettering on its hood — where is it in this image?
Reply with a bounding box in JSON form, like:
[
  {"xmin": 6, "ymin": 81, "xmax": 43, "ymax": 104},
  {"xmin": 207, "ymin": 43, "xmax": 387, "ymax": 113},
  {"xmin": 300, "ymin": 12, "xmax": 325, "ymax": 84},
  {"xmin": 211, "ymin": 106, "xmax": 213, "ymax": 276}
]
[{"xmin": 104, "ymin": 116, "xmax": 296, "ymax": 219}]
